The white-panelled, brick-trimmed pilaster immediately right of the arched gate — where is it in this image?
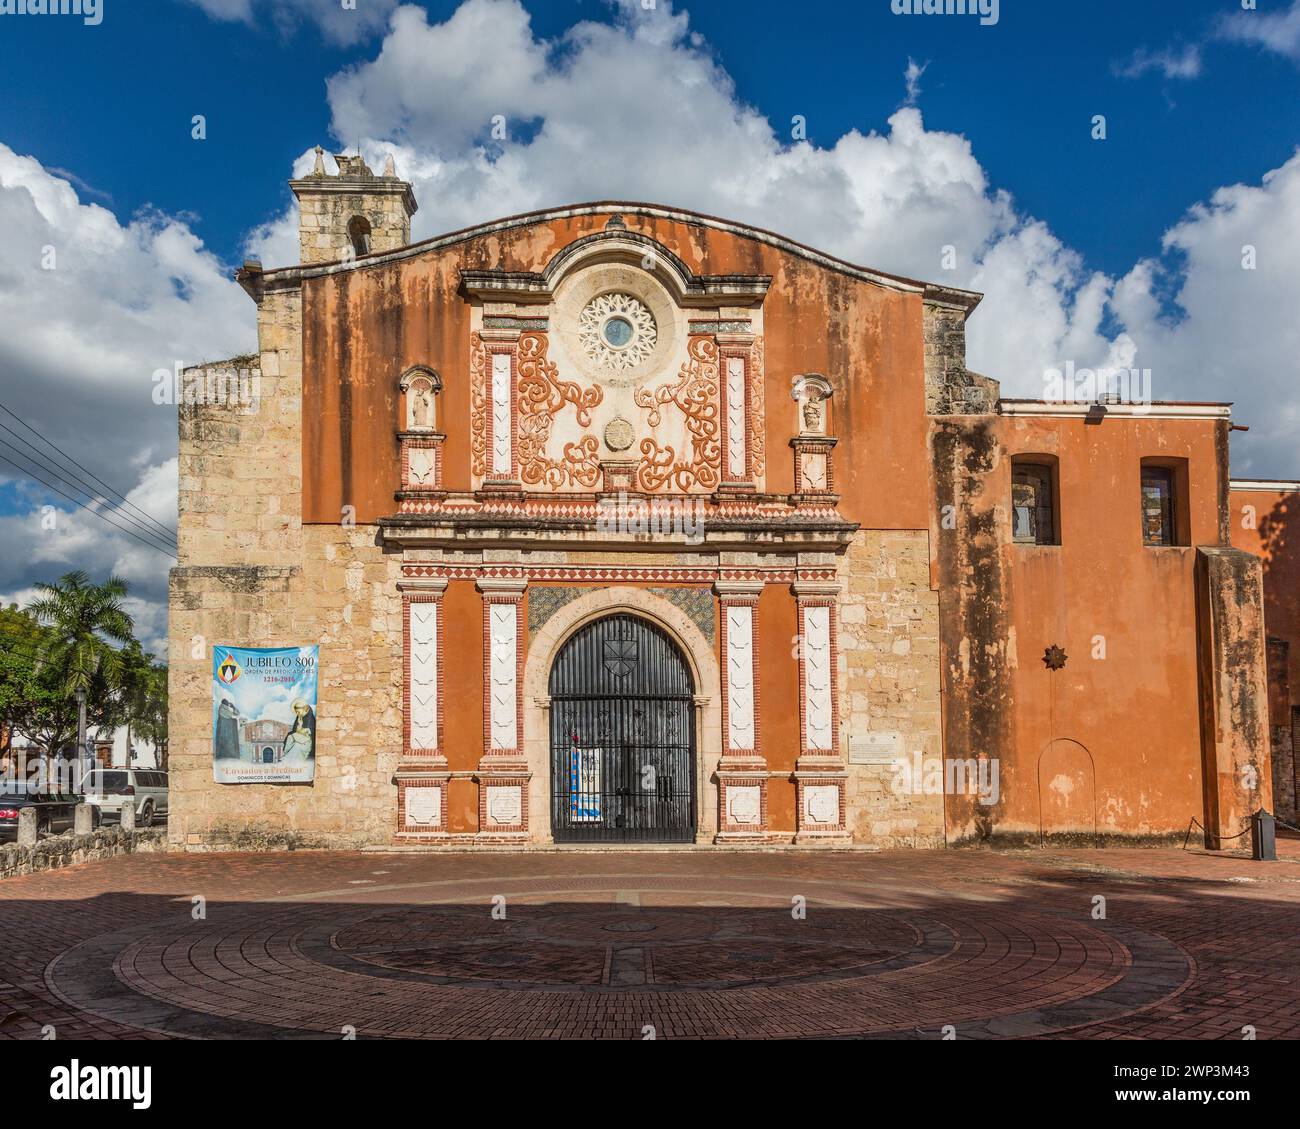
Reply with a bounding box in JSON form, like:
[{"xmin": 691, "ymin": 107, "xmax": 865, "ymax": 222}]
[{"xmin": 714, "ymin": 580, "xmax": 770, "ymax": 843}]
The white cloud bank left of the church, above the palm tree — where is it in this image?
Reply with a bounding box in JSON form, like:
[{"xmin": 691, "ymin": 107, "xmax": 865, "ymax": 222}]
[{"xmin": 0, "ymin": 144, "xmax": 255, "ymax": 649}]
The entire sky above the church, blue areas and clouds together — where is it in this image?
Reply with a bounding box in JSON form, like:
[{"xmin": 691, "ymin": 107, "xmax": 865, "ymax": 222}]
[{"xmin": 0, "ymin": 0, "xmax": 1300, "ymax": 652}]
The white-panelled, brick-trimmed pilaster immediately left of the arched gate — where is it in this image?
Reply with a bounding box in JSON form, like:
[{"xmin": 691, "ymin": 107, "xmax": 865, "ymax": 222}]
[{"xmin": 475, "ymin": 578, "xmax": 532, "ymax": 844}]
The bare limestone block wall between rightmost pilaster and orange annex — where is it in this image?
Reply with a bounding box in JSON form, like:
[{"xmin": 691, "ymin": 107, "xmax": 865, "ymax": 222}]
[{"xmin": 839, "ymin": 529, "xmax": 944, "ymax": 847}]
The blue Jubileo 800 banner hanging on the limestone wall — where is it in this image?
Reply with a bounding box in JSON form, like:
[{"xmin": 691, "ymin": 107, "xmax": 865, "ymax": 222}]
[{"xmin": 212, "ymin": 646, "xmax": 319, "ymax": 784}]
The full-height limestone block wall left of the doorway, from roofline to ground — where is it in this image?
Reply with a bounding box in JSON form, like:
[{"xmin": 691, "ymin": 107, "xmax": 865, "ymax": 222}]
[{"xmin": 168, "ymin": 282, "xmax": 402, "ymax": 848}]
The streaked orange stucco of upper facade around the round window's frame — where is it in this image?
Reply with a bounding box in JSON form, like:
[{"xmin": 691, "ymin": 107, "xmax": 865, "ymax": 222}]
[{"xmin": 303, "ymin": 211, "xmax": 930, "ymax": 529}]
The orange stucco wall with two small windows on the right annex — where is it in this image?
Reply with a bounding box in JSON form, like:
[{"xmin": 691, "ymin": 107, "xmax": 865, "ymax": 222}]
[{"xmin": 940, "ymin": 416, "xmax": 1226, "ymax": 835}]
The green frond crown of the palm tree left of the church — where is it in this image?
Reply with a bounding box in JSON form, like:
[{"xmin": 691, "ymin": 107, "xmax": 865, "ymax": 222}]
[{"xmin": 29, "ymin": 568, "xmax": 135, "ymax": 697}]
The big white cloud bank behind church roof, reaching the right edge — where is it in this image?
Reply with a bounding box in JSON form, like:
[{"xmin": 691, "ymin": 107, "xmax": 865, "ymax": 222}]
[{"xmin": 254, "ymin": 0, "xmax": 1300, "ymax": 475}]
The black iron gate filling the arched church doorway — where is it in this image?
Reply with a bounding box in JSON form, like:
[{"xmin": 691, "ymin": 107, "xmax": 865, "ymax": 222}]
[{"xmin": 550, "ymin": 615, "xmax": 696, "ymax": 843}]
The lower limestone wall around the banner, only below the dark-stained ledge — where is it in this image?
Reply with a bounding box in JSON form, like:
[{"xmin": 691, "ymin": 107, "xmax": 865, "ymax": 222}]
[{"xmin": 169, "ymin": 535, "xmax": 402, "ymax": 848}]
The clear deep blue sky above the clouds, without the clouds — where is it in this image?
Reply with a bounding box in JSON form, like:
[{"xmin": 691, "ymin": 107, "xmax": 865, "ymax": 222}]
[{"xmin": 0, "ymin": 0, "xmax": 1300, "ymax": 272}]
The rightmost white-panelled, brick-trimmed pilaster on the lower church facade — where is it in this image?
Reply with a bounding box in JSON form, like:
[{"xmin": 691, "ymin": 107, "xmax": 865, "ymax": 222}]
[{"xmin": 793, "ymin": 581, "xmax": 849, "ymax": 843}]
